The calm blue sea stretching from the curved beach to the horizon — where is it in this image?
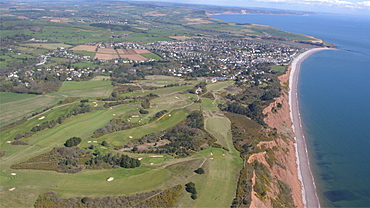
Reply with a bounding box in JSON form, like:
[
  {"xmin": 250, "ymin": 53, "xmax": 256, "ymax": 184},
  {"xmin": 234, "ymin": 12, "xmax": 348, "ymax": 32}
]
[{"xmin": 212, "ymin": 14, "xmax": 370, "ymax": 207}]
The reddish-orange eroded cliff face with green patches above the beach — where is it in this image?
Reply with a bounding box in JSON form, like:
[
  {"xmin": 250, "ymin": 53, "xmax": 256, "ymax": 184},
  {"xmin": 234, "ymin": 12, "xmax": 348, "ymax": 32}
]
[{"xmin": 247, "ymin": 69, "xmax": 304, "ymax": 207}]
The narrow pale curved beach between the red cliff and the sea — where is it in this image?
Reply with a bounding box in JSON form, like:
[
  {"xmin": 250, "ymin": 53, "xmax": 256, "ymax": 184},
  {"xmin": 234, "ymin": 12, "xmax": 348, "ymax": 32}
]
[{"xmin": 289, "ymin": 48, "xmax": 335, "ymax": 207}]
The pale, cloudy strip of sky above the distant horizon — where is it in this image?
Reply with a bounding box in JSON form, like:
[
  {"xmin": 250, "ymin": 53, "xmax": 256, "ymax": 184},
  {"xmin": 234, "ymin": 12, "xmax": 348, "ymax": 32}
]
[{"xmin": 141, "ymin": 0, "xmax": 370, "ymax": 15}]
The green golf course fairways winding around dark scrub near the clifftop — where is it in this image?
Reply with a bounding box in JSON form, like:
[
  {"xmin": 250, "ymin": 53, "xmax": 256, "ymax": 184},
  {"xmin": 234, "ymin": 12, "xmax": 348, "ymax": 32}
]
[{"xmin": 0, "ymin": 76, "xmax": 246, "ymax": 207}]
